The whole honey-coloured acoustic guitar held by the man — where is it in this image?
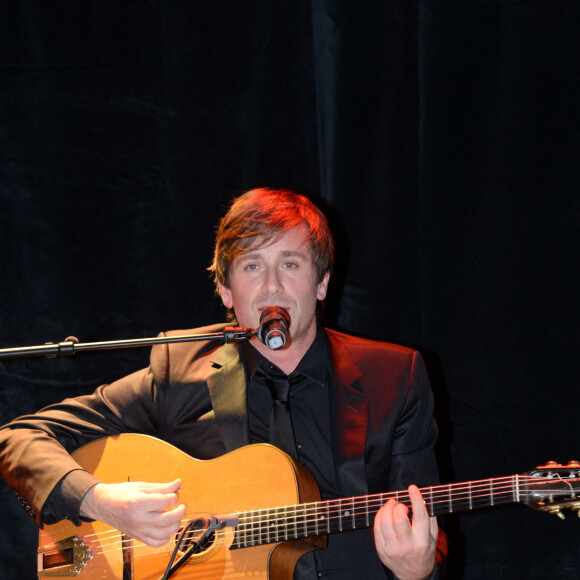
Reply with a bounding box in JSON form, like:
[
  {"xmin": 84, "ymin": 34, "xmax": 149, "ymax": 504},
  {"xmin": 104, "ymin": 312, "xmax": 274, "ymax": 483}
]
[{"xmin": 38, "ymin": 434, "xmax": 580, "ymax": 580}]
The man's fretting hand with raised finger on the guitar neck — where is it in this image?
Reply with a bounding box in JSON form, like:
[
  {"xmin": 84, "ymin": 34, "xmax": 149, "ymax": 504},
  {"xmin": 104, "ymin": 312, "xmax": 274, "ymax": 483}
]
[{"xmin": 374, "ymin": 485, "xmax": 438, "ymax": 580}]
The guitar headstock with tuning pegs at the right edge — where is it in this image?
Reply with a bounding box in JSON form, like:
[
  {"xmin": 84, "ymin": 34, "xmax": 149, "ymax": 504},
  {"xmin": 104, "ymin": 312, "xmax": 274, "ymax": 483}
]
[{"xmin": 520, "ymin": 461, "xmax": 580, "ymax": 519}]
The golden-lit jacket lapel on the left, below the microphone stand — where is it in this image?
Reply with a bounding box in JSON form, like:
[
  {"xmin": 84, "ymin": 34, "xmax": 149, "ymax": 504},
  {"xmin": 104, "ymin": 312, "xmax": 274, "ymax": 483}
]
[{"xmin": 207, "ymin": 344, "xmax": 250, "ymax": 452}]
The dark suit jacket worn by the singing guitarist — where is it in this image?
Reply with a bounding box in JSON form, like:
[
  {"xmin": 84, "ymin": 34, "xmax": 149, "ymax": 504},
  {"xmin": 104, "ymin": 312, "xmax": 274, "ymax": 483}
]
[{"xmin": 0, "ymin": 325, "xmax": 438, "ymax": 577}]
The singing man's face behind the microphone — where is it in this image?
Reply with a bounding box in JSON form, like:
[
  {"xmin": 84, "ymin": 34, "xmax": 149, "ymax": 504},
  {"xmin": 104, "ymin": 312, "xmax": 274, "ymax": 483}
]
[{"xmin": 219, "ymin": 225, "xmax": 329, "ymax": 350}]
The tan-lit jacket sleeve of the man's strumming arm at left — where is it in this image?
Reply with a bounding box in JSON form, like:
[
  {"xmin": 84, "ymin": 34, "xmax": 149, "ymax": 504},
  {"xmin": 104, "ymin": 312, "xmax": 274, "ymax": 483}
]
[{"xmin": 0, "ymin": 369, "xmax": 157, "ymax": 526}]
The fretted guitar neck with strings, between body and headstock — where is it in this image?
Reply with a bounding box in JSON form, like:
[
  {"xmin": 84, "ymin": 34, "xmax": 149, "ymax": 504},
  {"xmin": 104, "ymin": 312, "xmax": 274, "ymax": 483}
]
[{"xmin": 232, "ymin": 475, "xmax": 523, "ymax": 548}]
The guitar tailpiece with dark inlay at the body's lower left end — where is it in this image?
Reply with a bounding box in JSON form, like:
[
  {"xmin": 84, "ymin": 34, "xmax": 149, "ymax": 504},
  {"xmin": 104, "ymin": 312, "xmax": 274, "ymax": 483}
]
[{"xmin": 37, "ymin": 536, "xmax": 93, "ymax": 578}]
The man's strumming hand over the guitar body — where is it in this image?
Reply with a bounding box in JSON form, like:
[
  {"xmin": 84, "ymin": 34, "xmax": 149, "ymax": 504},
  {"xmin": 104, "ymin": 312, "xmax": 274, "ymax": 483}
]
[{"xmin": 81, "ymin": 479, "xmax": 185, "ymax": 547}]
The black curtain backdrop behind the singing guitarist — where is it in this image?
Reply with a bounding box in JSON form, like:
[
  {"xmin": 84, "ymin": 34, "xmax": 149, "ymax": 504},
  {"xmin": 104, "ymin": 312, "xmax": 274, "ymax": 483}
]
[{"xmin": 0, "ymin": 0, "xmax": 580, "ymax": 580}]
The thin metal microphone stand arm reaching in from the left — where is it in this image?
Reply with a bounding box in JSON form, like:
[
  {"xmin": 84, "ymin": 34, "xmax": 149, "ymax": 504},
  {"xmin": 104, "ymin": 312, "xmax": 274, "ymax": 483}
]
[{"xmin": 0, "ymin": 326, "xmax": 254, "ymax": 359}]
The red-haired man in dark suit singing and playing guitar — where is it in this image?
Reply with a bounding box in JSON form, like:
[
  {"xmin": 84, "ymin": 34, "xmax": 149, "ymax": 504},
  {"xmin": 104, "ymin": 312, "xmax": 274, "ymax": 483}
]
[{"xmin": 0, "ymin": 189, "xmax": 445, "ymax": 580}]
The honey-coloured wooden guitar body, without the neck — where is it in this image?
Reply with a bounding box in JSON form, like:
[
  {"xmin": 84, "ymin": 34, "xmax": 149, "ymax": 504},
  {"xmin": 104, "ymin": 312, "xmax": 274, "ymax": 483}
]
[{"xmin": 38, "ymin": 434, "xmax": 323, "ymax": 580}]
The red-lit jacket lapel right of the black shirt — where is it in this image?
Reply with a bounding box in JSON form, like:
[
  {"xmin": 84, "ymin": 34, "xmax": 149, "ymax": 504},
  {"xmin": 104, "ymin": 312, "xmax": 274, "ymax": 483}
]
[{"xmin": 328, "ymin": 333, "xmax": 368, "ymax": 495}]
